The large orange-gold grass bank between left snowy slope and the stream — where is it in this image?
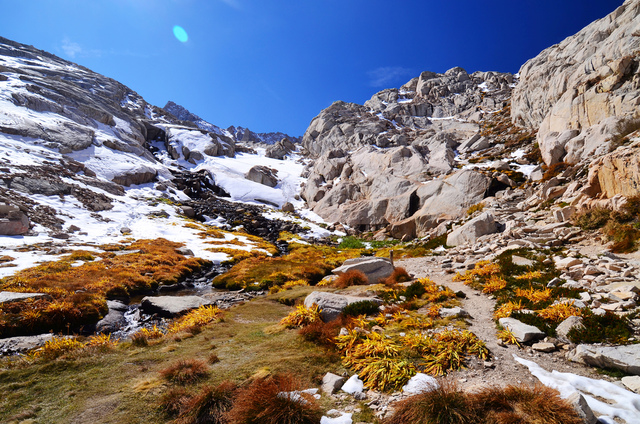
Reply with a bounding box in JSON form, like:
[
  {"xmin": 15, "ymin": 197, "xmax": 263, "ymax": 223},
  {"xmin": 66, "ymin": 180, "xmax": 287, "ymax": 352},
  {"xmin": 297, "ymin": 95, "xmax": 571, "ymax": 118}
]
[{"xmin": 0, "ymin": 239, "xmax": 208, "ymax": 337}]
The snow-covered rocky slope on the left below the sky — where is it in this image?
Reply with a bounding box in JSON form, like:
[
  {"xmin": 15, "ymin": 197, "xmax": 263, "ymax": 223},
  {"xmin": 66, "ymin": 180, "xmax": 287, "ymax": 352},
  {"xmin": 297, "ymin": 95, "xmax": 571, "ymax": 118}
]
[{"xmin": 0, "ymin": 34, "xmax": 328, "ymax": 276}]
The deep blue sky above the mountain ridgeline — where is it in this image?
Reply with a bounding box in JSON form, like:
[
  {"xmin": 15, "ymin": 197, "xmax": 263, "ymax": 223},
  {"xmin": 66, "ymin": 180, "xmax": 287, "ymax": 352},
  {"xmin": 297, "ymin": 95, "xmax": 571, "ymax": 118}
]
[{"xmin": 0, "ymin": 0, "xmax": 623, "ymax": 135}]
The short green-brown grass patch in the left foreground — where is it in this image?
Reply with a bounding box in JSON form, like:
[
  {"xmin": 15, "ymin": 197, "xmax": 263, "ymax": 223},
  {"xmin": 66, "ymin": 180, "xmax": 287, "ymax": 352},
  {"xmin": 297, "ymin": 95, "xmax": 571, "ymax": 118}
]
[{"xmin": 0, "ymin": 298, "xmax": 341, "ymax": 424}]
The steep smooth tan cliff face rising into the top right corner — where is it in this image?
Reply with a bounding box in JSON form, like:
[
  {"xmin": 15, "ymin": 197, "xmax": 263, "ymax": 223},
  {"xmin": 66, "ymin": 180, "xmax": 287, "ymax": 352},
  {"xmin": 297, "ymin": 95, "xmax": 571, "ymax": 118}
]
[{"xmin": 512, "ymin": 0, "xmax": 640, "ymax": 165}]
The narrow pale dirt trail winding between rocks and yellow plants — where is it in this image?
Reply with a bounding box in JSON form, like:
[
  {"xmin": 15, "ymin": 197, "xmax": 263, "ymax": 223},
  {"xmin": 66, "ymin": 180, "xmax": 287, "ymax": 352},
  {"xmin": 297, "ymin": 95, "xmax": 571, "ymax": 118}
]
[{"xmin": 395, "ymin": 258, "xmax": 610, "ymax": 388}]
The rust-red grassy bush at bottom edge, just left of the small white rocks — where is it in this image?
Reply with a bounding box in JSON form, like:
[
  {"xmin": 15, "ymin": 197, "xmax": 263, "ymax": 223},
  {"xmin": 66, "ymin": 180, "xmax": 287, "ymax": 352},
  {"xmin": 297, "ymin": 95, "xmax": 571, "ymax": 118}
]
[{"xmin": 226, "ymin": 374, "xmax": 322, "ymax": 424}]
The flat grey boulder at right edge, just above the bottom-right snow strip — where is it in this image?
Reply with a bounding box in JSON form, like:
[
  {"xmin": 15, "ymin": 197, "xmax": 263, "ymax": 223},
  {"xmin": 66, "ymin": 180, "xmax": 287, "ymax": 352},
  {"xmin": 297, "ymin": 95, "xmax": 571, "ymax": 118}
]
[{"xmin": 567, "ymin": 344, "xmax": 640, "ymax": 375}]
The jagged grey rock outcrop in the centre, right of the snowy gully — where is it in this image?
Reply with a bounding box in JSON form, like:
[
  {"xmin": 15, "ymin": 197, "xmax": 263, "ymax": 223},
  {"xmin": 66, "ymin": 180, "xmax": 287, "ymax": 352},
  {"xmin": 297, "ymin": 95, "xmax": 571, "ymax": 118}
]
[{"xmin": 302, "ymin": 68, "xmax": 514, "ymax": 238}]
